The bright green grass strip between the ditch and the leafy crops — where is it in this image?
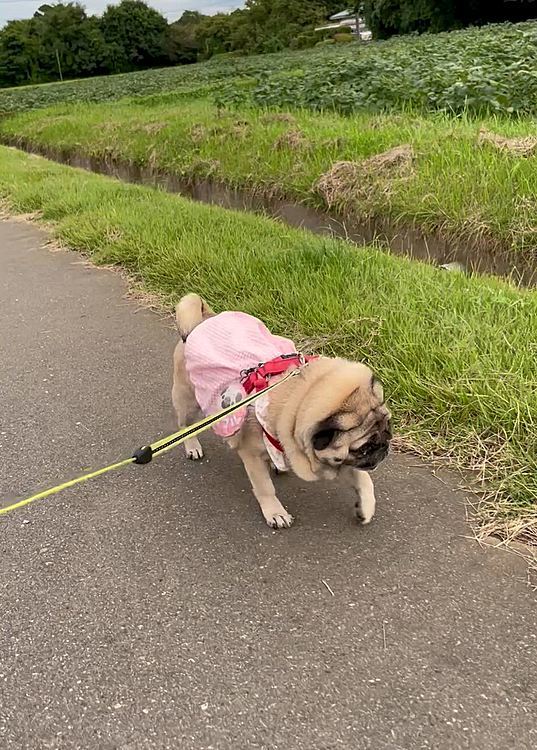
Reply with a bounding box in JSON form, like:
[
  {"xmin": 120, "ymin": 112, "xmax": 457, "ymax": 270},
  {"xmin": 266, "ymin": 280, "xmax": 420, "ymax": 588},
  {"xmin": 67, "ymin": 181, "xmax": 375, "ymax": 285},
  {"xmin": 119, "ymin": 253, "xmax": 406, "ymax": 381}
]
[{"xmin": 0, "ymin": 98, "xmax": 537, "ymax": 265}]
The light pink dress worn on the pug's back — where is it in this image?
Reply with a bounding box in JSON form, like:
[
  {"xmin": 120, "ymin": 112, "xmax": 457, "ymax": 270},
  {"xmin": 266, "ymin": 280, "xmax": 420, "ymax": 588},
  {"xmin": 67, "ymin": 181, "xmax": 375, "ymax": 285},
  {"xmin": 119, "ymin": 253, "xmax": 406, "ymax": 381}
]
[{"xmin": 185, "ymin": 312, "xmax": 296, "ymax": 438}]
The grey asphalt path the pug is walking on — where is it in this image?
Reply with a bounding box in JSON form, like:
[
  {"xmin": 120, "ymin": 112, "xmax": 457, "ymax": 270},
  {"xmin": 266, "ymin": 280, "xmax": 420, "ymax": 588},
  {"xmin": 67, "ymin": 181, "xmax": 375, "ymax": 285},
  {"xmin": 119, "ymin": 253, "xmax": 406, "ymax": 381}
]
[{"xmin": 0, "ymin": 217, "xmax": 537, "ymax": 750}]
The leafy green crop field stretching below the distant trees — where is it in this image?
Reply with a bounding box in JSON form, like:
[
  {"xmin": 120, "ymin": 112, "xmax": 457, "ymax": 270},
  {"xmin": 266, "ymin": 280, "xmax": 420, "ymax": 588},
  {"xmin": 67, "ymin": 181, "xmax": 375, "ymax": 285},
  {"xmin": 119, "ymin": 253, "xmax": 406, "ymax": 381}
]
[{"xmin": 0, "ymin": 22, "xmax": 537, "ymax": 115}]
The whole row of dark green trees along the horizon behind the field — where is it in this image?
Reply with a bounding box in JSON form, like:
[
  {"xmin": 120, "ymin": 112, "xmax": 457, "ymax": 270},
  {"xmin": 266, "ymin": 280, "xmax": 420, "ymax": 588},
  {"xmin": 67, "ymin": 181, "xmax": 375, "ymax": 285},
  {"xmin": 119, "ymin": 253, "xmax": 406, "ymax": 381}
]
[{"xmin": 0, "ymin": 0, "xmax": 537, "ymax": 86}]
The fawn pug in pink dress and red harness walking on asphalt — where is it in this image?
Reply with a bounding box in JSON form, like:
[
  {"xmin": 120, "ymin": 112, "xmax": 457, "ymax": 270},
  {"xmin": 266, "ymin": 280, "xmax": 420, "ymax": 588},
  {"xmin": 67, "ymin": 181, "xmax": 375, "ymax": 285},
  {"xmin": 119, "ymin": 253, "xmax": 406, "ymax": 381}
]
[{"xmin": 172, "ymin": 294, "xmax": 392, "ymax": 529}]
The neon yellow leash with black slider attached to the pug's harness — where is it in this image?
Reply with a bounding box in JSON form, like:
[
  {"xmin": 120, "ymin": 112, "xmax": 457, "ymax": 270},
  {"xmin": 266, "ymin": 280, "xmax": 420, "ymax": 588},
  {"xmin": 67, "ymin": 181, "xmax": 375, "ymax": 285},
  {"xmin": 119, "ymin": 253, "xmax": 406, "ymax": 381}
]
[{"xmin": 0, "ymin": 369, "xmax": 300, "ymax": 516}]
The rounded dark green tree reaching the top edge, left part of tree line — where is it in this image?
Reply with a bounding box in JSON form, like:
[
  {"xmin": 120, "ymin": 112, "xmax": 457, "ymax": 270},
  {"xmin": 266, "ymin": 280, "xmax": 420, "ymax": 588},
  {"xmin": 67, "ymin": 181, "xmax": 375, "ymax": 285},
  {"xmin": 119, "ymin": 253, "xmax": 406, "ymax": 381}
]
[{"xmin": 100, "ymin": 0, "xmax": 169, "ymax": 73}]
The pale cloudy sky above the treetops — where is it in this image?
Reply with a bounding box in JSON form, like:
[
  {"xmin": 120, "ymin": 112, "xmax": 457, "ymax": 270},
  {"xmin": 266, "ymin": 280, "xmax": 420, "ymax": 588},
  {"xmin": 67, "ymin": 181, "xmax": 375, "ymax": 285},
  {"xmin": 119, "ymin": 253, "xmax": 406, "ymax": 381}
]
[{"xmin": 0, "ymin": 0, "xmax": 244, "ymax": 26}]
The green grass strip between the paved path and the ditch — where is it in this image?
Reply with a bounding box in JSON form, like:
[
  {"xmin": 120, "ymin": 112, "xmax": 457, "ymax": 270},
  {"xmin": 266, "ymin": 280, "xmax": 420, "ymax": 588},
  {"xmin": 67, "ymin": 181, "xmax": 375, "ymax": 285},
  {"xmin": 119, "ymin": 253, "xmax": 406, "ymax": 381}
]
[{"xmin": 0, "ymin": 148, "xmax": 537, "ymax": 540}]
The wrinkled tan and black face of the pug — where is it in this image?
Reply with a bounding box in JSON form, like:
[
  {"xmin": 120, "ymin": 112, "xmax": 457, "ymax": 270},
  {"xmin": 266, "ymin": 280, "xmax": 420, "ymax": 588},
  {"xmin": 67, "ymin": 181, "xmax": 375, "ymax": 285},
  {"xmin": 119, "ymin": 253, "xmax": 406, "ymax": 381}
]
[{"xmin": 312, "ymin": 376, "xmax": 392, "ymax": 471}]
